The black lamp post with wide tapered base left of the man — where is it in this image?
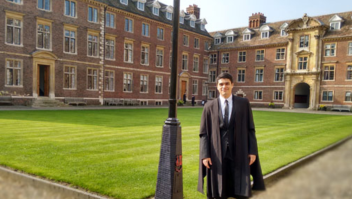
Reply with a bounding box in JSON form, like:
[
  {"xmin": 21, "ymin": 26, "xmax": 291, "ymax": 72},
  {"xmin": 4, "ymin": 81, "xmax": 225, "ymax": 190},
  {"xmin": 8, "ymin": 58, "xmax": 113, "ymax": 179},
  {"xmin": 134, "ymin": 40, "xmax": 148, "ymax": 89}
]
[{"xmin": 155, "ymin": 0, "xmax": 183, "ymax": 199}]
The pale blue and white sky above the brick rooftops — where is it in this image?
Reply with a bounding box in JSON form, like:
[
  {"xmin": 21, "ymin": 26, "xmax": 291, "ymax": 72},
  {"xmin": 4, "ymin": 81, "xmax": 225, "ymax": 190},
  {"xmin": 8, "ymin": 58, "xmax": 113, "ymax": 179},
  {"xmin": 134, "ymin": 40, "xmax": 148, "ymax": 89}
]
[{"xmin": 159, "ymin": 0, "xmax": 352, "ymax": 32}]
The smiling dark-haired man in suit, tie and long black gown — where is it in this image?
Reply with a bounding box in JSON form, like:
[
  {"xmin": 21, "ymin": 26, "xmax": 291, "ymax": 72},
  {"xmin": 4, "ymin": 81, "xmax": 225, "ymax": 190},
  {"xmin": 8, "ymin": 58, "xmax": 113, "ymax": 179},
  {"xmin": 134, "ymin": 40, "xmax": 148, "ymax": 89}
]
[{"xmin": 198, "ymin": 73, "xmax": 265, "ymax": 199}]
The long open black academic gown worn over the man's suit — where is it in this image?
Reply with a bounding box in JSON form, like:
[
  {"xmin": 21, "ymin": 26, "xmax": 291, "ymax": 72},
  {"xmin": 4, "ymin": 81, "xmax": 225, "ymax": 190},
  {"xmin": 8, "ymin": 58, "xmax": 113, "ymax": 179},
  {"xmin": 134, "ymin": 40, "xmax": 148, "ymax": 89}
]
[{"xmin": 198, "ymin": 96, "xmax": 265, "ymax": 198}]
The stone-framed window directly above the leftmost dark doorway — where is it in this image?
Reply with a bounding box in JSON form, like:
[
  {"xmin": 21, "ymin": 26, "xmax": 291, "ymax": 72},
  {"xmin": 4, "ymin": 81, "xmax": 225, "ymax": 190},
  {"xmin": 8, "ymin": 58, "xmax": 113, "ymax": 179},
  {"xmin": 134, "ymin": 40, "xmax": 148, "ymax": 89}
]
[{"xmin": 37, "ymin": 21, "xmax": 51, "ymax": 50}]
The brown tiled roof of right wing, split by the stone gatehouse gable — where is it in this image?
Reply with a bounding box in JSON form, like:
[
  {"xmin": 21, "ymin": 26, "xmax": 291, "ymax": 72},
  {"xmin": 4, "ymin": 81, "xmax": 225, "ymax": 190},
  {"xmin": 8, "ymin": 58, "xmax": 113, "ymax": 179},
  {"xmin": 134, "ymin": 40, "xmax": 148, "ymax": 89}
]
[{"xmin": 210, "ymin": 11, "xmax": 352, "ymax": 50}]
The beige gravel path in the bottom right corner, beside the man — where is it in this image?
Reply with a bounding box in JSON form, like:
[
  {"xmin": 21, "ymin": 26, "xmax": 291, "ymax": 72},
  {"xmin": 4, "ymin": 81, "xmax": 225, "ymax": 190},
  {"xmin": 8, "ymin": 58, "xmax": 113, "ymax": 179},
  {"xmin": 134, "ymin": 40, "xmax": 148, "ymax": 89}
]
[{"xmin": 253, "ymin": 139, "xmax": 352, "ymax": 199}]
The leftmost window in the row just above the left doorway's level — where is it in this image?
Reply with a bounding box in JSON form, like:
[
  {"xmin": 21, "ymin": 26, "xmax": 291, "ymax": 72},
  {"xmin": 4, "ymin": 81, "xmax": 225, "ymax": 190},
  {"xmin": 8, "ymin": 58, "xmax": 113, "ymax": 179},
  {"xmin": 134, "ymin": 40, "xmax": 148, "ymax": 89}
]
[{"xmin": 5, "ymin": 16, "xmax": 22, "ymax": 45}]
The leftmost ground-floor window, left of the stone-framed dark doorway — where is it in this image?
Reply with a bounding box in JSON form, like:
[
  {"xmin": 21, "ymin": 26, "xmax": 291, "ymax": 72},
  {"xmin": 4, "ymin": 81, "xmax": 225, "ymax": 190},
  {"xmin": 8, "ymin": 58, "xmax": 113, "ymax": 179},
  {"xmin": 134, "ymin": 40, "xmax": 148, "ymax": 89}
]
[{"xmin": 6, "ymin": 59, "xmax": 22, "ymax": 86}]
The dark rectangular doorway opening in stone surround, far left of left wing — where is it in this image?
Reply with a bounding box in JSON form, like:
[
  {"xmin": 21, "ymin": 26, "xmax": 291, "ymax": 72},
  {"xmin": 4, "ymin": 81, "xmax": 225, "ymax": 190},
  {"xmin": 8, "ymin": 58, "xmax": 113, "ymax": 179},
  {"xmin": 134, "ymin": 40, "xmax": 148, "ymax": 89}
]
[{"xmin": 37, "ymin": 65, "xmax": 50, "ymax": 97}]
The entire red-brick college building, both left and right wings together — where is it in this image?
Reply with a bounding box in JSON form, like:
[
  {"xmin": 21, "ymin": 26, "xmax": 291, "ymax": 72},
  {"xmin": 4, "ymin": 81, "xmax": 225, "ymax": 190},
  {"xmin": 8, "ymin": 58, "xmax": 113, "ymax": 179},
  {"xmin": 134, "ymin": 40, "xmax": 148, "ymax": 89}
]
[{"xmin": 0, "ymin": 0, "xmax": 352, "ymax": 109}]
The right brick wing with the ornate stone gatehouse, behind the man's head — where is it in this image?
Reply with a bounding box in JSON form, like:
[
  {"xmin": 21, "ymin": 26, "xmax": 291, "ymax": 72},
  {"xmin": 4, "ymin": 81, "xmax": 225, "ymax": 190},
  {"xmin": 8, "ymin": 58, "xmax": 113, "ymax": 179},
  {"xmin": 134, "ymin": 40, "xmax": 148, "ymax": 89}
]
[{"xmin": 209, "ymin": 12, "xmax": 352, "ymax": 109}]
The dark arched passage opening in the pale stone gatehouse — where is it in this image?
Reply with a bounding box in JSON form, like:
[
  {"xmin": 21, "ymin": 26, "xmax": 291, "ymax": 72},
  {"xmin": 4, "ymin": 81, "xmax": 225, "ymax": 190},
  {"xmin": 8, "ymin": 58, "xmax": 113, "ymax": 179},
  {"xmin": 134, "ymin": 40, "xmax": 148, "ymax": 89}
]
[{"xmin": 293, "ymin": 83, "xmax": 310, "ymax": 108}]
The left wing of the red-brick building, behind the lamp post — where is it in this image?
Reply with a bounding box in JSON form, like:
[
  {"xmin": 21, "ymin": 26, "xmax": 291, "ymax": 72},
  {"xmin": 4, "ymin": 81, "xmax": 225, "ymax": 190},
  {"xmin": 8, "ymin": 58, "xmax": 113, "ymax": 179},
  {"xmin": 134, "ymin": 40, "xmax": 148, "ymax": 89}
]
[{"xmin": 0, "ymin": 0, "xmax": 212, "ymax": 105}]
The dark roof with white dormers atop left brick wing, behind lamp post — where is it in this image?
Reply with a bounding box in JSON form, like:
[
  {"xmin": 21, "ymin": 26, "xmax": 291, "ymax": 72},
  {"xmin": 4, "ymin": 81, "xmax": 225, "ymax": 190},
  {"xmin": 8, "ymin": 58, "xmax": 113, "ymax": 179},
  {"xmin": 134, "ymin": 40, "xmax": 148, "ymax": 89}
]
[{"xmin": 95, "ymin": 0, "xmax": 211, "ymax": 37}]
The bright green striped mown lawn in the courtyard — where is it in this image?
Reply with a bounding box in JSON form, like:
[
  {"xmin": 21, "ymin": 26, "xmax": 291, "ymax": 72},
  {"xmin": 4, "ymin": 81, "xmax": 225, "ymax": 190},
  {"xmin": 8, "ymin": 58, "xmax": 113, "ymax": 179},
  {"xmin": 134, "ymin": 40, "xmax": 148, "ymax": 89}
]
[{"xmin": 0, "ymin": 108, "xmax": 352, "ymax": 199}]
